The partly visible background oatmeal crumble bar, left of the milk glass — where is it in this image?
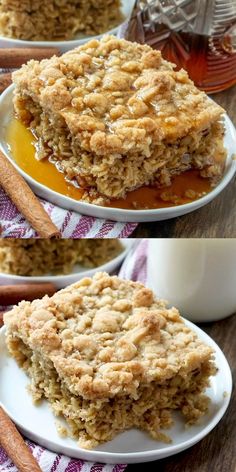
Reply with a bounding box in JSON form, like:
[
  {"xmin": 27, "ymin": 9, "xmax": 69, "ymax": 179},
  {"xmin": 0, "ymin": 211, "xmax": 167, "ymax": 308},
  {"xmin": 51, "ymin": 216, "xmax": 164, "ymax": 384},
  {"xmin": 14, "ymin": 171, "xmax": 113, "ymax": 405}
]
[{"xmin": 0, "ymin": 239, "xmax": 123, "ymax": 276}]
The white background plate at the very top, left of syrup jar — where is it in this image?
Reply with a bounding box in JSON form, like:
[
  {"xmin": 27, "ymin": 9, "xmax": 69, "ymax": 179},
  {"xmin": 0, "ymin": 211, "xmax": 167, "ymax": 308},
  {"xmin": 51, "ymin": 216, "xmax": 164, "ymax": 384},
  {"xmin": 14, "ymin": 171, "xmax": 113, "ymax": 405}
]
[{"xmin": 0, "ymin": 0, "xmax": 135, "ymax": 52}]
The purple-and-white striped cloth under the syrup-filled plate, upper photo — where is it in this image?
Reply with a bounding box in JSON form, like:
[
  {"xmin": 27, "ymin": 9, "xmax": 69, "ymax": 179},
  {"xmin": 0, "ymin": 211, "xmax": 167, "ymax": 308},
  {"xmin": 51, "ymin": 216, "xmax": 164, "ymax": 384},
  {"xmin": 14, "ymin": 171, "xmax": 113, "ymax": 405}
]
[{"xmin": 0, "ymin": 188, "xmax": 137, "ymax": 239}]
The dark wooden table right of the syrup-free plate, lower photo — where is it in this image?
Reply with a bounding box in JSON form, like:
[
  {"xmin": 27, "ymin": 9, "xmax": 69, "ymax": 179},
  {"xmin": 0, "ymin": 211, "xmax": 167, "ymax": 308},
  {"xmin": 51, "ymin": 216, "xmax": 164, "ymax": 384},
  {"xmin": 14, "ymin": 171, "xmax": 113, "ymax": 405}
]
[{"xmin": 127, "ymin": 315, "xmax": 236, "ymax": 472}]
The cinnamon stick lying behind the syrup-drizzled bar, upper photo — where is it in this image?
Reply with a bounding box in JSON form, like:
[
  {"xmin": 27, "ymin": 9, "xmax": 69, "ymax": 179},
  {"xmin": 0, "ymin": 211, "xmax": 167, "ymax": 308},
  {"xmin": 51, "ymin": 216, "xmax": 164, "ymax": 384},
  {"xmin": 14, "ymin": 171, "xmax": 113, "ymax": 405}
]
[{"xmin": 0, "ymin": 48, "xmax": 60, "ymax": 69}]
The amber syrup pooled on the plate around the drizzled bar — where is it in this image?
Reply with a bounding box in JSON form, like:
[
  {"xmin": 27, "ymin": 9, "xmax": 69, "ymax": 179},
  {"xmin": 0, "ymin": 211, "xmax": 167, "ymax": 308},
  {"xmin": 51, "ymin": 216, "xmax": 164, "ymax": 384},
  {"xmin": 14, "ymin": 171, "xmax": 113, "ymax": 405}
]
[{"xmin": 6, "ymin": 118, "xmax": 212, "ymax": 210}]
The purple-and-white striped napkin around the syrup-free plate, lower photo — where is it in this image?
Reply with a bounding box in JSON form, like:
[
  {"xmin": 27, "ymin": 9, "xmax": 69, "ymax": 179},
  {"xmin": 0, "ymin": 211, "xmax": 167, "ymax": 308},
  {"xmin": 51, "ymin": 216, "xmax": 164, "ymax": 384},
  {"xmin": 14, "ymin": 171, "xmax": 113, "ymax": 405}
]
[{"xmin": 0, "ymin": 239, "xmax": 148, "ymax": 472}]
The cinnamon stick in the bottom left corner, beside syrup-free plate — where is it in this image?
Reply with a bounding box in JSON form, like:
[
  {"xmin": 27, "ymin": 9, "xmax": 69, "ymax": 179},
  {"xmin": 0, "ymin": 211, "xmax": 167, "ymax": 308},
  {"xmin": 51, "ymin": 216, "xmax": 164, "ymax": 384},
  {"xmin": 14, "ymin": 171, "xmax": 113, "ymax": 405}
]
[{"xmin": 0, "ymin": 407, "xmax": 42, "ymax": 472}]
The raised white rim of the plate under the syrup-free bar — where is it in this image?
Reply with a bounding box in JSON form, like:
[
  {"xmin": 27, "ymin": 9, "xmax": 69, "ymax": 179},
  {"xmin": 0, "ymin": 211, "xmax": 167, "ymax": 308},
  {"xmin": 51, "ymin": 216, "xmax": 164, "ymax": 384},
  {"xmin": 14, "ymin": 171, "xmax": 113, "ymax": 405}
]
[{"xmin": 0, "ymin": 317, "xmax": 233, "ymax": 464}]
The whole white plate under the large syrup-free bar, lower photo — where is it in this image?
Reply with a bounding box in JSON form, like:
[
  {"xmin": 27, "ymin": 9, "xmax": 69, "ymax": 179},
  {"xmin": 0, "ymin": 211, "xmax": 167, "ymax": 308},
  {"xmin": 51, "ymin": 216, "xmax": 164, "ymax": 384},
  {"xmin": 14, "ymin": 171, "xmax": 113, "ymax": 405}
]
[{"xmin": 0, "ymin": 321, "xmax": 232, "ymax": 464}]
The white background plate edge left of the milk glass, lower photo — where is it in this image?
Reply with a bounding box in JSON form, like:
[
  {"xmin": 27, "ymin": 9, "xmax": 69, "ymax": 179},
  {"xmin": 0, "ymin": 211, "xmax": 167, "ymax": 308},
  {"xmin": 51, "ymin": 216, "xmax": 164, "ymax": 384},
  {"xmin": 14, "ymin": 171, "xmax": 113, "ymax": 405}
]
[{"xmin": 0, "ymin": 239, "xmax": 135, "ymax": 289}]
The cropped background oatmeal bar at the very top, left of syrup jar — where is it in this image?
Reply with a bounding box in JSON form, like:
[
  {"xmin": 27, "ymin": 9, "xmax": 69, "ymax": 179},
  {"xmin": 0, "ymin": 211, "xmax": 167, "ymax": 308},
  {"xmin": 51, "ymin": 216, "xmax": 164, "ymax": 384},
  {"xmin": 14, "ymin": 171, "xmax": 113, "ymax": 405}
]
[{"xmin": 0, "ymin": 0, "xmax": 123, "ymax": 41}]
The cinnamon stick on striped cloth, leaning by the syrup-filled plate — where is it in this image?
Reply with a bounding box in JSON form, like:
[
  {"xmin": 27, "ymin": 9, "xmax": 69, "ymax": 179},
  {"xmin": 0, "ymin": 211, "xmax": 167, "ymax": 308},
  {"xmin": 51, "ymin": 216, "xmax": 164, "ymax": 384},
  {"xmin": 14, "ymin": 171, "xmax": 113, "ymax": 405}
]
[{"xmin": 0, "ymin": 151, "xmax": 61, "ymax": 238}]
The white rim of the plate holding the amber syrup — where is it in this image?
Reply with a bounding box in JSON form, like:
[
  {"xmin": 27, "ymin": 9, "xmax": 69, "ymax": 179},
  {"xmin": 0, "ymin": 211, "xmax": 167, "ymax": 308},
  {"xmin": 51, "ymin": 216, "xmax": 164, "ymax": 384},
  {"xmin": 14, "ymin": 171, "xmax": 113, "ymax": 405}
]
[{"xmin": 0, "ymin": 84, "xmax": 236, "ymax": 223}]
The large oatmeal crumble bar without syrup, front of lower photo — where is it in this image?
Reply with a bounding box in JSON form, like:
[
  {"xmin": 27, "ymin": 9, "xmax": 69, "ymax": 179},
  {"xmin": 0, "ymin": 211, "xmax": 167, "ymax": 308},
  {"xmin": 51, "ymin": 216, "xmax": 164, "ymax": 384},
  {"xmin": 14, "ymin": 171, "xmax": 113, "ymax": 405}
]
[{"xmin": 4, "ymin": 273, "xmax": 216, "ymax": 448}]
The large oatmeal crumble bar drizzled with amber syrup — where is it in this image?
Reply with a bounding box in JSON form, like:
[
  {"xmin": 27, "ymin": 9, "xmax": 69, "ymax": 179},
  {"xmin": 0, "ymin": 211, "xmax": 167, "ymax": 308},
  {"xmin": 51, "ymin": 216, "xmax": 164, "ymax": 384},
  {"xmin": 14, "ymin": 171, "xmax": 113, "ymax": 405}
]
[{"xmin": 13, "ymin": 36, "xmax": 226, "ymax": 203}]
